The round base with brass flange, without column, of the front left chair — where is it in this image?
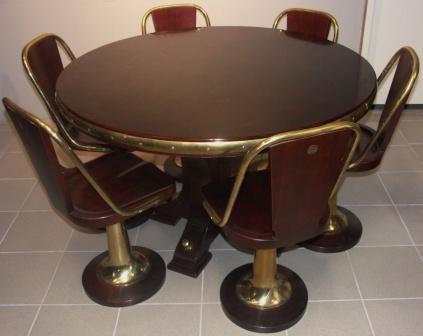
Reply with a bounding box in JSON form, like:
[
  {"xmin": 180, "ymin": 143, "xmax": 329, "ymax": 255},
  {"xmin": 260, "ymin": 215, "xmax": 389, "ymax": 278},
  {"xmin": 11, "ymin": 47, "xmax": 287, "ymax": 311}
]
[{"xmin": 82, "ymin": 246, "xmax": 166, "ymax": 307}]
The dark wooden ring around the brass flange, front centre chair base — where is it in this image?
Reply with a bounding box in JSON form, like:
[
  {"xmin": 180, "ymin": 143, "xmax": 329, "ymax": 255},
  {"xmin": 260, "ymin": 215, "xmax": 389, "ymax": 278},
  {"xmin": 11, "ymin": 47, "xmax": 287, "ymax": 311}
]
[{"xmin": 220, "ymin": 264, "xmax": 308, "ymax": 333}]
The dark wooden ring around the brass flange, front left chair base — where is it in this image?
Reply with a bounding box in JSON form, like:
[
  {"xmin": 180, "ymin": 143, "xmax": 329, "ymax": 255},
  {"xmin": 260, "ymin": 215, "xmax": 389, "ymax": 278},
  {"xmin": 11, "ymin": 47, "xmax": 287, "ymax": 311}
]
[{"xmin": 82, "ymin": 246, "xmax": 166, "ymax": 307}]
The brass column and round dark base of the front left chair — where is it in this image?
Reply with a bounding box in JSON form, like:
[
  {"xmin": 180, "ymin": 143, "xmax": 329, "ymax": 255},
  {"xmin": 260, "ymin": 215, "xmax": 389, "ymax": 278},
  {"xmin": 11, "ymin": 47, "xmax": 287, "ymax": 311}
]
[{"xmin": 82, "ymin": 223, "xmax": 166, "ymax": 307}]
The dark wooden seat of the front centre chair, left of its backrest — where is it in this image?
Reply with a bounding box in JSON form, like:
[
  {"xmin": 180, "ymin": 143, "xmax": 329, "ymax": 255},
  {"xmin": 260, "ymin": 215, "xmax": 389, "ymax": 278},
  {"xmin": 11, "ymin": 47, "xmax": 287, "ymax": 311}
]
[{"xmin": 203, "ymin": 170, "xmax": 274, "ymax": 248}]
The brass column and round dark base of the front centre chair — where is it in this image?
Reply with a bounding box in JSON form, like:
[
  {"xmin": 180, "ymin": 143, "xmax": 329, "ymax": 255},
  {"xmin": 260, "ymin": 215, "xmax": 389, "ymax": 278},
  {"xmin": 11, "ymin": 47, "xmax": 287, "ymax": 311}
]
[{"xmin": 220, "ymin": 250, "xmax": 308, "ymax": 333}]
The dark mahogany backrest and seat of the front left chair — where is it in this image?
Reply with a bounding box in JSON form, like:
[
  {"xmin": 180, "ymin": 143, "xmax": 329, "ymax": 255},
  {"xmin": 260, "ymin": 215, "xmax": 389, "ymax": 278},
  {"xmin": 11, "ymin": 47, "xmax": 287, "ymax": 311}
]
[{"xmin": 3, "ymin": 100, "xmax": 175, "ymax": 228}]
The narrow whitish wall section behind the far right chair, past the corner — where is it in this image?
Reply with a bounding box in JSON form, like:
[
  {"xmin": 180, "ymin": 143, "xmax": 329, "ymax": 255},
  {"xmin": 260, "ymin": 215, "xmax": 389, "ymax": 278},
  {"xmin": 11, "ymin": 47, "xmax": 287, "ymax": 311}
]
[{"xmin": 362, "ymin": 0, "xmax": 423, "ymax": 104}]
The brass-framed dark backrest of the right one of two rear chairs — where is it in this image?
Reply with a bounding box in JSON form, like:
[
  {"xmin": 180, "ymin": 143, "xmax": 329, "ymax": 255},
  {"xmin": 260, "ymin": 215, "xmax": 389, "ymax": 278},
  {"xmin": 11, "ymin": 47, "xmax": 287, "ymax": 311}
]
[{"xmin": 273, "ymin": 8, "xmax": 339, "ymax": 42}]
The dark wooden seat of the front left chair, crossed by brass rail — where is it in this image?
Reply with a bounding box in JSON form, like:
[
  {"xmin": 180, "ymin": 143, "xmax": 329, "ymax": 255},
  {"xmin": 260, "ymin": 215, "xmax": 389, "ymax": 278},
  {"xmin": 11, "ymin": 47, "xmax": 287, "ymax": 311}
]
[{"xmin": 67, "ymin": 151, "xmax": 175, "ymax": 227}]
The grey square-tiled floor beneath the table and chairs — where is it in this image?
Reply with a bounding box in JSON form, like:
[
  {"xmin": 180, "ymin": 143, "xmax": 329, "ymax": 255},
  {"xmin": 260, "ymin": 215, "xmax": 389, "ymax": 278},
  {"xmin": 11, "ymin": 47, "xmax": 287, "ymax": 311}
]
[{"xmin": 0, "ymin": 111, "xmax": 423, "ymax": 336}]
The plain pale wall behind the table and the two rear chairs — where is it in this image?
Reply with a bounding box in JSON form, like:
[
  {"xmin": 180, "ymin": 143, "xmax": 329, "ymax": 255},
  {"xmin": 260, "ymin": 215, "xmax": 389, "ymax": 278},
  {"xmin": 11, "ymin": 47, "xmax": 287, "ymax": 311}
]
[{"xmin": 0, "ymin": 0, "xmax": 368, "ymax": 119}]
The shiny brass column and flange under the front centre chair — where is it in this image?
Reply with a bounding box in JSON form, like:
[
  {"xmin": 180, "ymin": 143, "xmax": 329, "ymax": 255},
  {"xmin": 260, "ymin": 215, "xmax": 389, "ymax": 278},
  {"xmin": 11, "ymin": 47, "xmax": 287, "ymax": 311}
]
[{"xmin": 235, "ymin": 249, "xmax": 292, "ymax": 309}]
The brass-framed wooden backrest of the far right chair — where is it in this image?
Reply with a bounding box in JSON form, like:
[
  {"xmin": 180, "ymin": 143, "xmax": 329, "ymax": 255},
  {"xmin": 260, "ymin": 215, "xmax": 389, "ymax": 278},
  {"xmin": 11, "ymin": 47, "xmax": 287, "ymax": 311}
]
[{"xmin": 350, "ymin": 47, "xmax": 419, "ymax": 168}]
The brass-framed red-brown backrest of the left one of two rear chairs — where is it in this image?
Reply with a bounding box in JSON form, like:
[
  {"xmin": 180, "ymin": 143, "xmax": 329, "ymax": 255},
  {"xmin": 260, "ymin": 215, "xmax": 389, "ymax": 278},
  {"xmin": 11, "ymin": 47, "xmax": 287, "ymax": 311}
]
[{"xmin": 141, "ymin": 4, "xmax": 210, "ymax": 34}]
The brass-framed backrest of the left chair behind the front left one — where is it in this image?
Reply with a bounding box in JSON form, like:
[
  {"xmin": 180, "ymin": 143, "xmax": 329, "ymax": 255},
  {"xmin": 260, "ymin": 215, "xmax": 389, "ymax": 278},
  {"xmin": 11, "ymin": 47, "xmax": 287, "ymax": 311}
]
[{"xmin": 22, "ymin": 33, "xmax": 75, "ymax": 135}]
